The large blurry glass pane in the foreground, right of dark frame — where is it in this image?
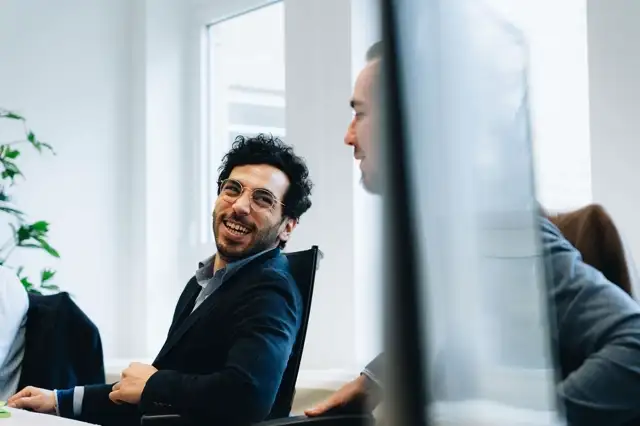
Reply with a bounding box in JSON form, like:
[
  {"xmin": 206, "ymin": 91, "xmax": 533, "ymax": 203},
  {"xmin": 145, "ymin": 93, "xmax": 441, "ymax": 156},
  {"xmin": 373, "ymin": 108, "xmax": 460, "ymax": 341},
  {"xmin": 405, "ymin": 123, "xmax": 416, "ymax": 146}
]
[{"xmin": 390, "ymin": 0, "xmax": 558, "ymax": 426}]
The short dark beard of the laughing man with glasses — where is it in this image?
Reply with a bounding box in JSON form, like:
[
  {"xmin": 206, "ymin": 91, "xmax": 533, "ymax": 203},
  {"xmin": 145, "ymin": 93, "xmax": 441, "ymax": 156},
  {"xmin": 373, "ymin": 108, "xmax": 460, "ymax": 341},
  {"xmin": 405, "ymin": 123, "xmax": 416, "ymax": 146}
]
[{"xmin": 212, "ymin": 210, "xmax": 284, "ymax": 262}]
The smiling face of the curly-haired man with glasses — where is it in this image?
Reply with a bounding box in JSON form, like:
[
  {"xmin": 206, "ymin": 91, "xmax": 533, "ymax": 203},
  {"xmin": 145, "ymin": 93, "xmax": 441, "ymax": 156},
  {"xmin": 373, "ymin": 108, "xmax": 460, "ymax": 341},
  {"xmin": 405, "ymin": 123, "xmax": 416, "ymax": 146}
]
[{"xmin": 213, "ymin": 164, "xmax": 295, "ymax": 261}]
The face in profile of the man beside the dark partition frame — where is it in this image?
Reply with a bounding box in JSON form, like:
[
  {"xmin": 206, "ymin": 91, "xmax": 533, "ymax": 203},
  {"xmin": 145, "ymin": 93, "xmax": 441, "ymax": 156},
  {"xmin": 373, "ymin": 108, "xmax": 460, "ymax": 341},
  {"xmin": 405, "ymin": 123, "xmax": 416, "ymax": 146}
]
[{"xmin": 344, "ymin": 59, "xmax": 380, "ymax": 193}]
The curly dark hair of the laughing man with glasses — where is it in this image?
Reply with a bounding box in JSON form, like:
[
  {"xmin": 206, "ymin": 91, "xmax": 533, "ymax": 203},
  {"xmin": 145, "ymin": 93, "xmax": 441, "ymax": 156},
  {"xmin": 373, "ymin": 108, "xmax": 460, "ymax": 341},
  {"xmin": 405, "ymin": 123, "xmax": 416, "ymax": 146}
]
[{"xmin": 218, "ymin": 134, "xmax": 313, "ymax": 221}]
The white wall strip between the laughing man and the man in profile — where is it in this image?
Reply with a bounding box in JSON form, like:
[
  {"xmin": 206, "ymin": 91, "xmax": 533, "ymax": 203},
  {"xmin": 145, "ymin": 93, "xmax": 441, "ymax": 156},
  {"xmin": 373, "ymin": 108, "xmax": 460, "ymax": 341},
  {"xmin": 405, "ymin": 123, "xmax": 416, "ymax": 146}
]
[{"xmin": 285, "ymin": 0, "xmax": 358, "ymax": 370}]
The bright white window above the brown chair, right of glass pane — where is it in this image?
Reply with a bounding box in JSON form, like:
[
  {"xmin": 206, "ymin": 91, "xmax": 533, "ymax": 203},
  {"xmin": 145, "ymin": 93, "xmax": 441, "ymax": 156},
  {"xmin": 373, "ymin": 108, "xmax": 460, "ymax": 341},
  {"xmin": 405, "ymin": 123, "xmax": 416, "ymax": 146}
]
[{"xmin": 488, "ymin": 0, "xmax": 592, "ymax": 211}]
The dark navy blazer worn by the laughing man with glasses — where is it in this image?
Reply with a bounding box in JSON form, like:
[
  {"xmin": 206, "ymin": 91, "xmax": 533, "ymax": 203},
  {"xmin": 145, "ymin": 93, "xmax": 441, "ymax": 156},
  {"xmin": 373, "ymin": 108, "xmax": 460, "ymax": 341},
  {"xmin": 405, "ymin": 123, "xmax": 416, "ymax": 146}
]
[{"xmin": 72, "ymin": 249, "xmax": 303, "ymax": 425}]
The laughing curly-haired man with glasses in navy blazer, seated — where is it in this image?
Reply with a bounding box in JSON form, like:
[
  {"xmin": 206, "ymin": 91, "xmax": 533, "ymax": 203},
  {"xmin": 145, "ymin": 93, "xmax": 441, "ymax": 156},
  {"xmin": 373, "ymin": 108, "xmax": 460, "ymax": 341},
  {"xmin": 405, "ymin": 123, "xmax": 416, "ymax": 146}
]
[{"xmin": 8, "ymin": 135, "xmax": 312, "ymax": 425}]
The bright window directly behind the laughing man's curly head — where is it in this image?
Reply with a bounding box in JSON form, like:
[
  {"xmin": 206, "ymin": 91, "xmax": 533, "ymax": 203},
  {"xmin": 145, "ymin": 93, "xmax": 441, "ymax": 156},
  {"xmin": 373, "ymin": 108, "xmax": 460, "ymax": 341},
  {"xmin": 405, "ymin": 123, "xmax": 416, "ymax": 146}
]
[{"xmin": 200, "ymin": 2, "xmax": 286, "ymax": 244}]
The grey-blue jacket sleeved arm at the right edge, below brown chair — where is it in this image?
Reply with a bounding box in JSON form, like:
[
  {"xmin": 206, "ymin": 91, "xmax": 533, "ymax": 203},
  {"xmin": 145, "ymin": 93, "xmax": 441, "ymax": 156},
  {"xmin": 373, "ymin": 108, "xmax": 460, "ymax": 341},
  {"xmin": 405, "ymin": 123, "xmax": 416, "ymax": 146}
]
[{"xmin": 542, "ymin": 219, "xmax": 640, "ymax": 426}]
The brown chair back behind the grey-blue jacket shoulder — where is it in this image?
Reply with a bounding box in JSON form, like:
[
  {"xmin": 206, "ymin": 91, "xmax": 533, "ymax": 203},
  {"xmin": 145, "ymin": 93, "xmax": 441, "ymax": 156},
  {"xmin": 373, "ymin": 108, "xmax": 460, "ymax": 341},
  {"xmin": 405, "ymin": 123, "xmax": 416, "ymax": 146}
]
[{"xmin": 547, "ymin": 204, "xmax": 640, "ymax": 297}]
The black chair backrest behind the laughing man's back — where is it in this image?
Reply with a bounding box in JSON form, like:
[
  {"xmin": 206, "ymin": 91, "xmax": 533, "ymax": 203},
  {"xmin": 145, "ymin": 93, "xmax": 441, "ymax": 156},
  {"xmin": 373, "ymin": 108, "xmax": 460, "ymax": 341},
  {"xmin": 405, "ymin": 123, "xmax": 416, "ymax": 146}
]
[{"xmin": 268, "ymin": 246, "xmax": 322, "ymax": 419}]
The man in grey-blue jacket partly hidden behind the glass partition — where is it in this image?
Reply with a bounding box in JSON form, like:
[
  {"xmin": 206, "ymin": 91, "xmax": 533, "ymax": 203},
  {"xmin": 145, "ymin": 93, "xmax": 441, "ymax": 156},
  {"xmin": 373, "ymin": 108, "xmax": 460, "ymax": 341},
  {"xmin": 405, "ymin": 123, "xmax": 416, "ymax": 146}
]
[{"xmin": 306, "ymin": 43, "xmax": 640, "ymax": 426}]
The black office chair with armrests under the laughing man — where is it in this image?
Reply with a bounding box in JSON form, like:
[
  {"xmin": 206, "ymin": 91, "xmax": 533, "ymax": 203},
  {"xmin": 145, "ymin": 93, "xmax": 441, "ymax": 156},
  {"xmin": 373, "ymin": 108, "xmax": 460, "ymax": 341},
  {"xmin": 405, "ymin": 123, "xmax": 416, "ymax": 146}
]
[{"xmin": 141, "ymin": 246, "xmax": 372, "ymax": 426}]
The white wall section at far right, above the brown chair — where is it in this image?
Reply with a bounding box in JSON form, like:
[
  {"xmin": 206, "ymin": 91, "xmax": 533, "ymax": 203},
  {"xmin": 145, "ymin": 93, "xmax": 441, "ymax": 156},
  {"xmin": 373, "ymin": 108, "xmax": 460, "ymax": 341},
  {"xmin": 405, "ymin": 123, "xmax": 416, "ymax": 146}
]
[{"xmin": 587, "ymin": 0, "xmax": 640, "ymax": 261}]
